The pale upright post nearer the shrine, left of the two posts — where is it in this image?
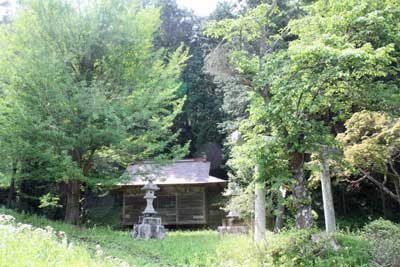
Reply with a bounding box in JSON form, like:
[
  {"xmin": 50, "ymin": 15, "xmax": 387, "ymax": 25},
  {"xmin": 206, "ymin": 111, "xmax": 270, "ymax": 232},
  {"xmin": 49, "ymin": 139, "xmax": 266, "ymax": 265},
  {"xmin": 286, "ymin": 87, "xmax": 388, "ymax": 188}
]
[{"xmin": 254, "ymin": 182, "xmax": 266, "ymax": 243}]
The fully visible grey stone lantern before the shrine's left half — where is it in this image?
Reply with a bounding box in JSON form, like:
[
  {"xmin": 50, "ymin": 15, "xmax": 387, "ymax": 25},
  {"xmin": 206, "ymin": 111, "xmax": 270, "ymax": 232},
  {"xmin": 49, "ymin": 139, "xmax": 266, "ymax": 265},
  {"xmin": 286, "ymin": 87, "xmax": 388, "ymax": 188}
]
[{"xmin": 132, "ymin": 179, "xmax": 165, "ymax": 239}]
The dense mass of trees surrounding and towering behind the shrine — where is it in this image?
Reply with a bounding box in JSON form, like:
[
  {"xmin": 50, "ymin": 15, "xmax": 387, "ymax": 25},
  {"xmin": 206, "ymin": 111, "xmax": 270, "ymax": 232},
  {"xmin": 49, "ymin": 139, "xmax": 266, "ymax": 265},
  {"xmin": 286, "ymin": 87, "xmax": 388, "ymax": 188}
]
[{"xmin": 0, "ymin": 0, "xmax": 400, "ymax": 266}]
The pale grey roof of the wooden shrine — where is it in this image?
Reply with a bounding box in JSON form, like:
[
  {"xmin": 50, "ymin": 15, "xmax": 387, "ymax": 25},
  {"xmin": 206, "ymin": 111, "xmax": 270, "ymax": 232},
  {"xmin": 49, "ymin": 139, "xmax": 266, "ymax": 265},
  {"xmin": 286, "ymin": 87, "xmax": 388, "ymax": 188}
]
[{"xmin": 121, "ymin": 159, "xmax": 226, "ymax": 185}]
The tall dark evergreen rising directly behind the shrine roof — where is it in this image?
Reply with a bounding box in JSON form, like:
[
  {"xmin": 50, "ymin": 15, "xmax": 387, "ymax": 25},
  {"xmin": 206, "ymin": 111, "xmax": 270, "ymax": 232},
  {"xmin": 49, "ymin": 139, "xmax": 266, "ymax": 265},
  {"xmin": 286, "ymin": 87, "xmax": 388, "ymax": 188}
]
[{"xmin": 154, "ymin": 0, "xmax": 227, "ymax": 161}]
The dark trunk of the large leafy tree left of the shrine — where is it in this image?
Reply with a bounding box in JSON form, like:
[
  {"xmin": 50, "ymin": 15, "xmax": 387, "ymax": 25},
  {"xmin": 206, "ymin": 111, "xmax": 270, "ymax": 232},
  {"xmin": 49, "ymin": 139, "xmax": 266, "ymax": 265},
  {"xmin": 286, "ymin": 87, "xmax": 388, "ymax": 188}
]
[{"xmin": 65, "ymin": 180, "xmax": 81, "ymax": 224}]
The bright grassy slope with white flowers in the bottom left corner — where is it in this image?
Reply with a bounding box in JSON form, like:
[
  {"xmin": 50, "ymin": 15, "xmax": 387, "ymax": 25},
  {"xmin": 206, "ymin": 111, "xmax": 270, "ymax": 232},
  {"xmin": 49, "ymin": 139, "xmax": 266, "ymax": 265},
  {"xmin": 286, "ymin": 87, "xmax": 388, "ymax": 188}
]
[{"xmin": 0, "ymin": 215, "xmax": 123, "ymax": 267}]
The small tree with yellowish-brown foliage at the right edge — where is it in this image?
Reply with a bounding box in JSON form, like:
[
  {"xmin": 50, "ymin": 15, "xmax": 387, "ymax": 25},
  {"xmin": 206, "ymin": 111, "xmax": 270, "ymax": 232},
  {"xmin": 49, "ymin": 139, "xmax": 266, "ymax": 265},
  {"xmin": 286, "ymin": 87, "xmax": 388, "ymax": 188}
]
[{"xmin": 337, "ymin": 111, "xmax": 400, "ymax": 204}]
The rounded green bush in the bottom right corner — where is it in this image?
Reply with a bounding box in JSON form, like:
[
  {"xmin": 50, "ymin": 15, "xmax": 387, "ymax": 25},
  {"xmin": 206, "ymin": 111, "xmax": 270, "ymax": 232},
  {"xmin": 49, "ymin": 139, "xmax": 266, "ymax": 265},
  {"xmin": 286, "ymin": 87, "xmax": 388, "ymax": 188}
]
[{"xmin": 364, "ymin": 219, "xmax": 400, "ymax": 267}]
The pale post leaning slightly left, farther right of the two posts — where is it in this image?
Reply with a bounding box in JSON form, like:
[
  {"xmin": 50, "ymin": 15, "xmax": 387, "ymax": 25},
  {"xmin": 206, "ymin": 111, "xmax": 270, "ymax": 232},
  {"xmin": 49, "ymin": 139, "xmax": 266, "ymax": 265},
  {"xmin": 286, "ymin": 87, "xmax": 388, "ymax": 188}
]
[{"xmin": 321, "ymin": 146, "xmax": 336, "ymax": 233}]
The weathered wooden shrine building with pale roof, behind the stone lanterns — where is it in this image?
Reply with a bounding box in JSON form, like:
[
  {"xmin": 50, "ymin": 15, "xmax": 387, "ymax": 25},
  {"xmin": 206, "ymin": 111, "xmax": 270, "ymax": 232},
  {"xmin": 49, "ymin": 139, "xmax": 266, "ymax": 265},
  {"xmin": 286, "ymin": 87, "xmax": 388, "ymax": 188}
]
[{"xmin": 118, "ymin": 158, "xmax": 226, "ymax": 225}]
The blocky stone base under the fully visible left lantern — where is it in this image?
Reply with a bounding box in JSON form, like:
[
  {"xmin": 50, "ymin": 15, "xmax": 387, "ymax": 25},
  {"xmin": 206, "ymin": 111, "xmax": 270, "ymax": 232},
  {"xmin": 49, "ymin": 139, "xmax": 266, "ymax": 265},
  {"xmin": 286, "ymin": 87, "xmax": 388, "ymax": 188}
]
[{"xmin": 132, "ymin": 217, "xmax": 166, "ymax": 240}]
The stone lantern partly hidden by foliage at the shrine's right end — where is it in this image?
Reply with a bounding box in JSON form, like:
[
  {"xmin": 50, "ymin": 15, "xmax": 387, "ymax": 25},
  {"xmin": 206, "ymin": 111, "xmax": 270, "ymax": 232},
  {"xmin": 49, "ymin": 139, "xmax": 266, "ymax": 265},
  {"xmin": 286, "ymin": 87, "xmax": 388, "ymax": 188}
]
[{"xmin": 218, "ymin": 183, "xmax": 248, "ymax": 235}]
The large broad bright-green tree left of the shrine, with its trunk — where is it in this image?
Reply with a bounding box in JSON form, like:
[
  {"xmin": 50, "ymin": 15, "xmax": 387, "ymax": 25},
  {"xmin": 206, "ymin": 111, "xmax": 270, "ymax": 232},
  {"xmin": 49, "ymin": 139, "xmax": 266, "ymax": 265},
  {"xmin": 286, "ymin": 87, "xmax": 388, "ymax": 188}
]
[{"xmin": 0, "ymin": 0, "xmax": 187, "ymax": 223}]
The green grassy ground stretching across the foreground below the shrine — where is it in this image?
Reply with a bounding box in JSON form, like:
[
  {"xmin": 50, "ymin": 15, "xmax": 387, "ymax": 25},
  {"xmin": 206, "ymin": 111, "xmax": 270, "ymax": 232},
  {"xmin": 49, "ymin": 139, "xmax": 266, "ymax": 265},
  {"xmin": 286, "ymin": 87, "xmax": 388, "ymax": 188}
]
[{"xmin": 0, "ymin": 209, "xmax": 369, "ymax": 267}]
